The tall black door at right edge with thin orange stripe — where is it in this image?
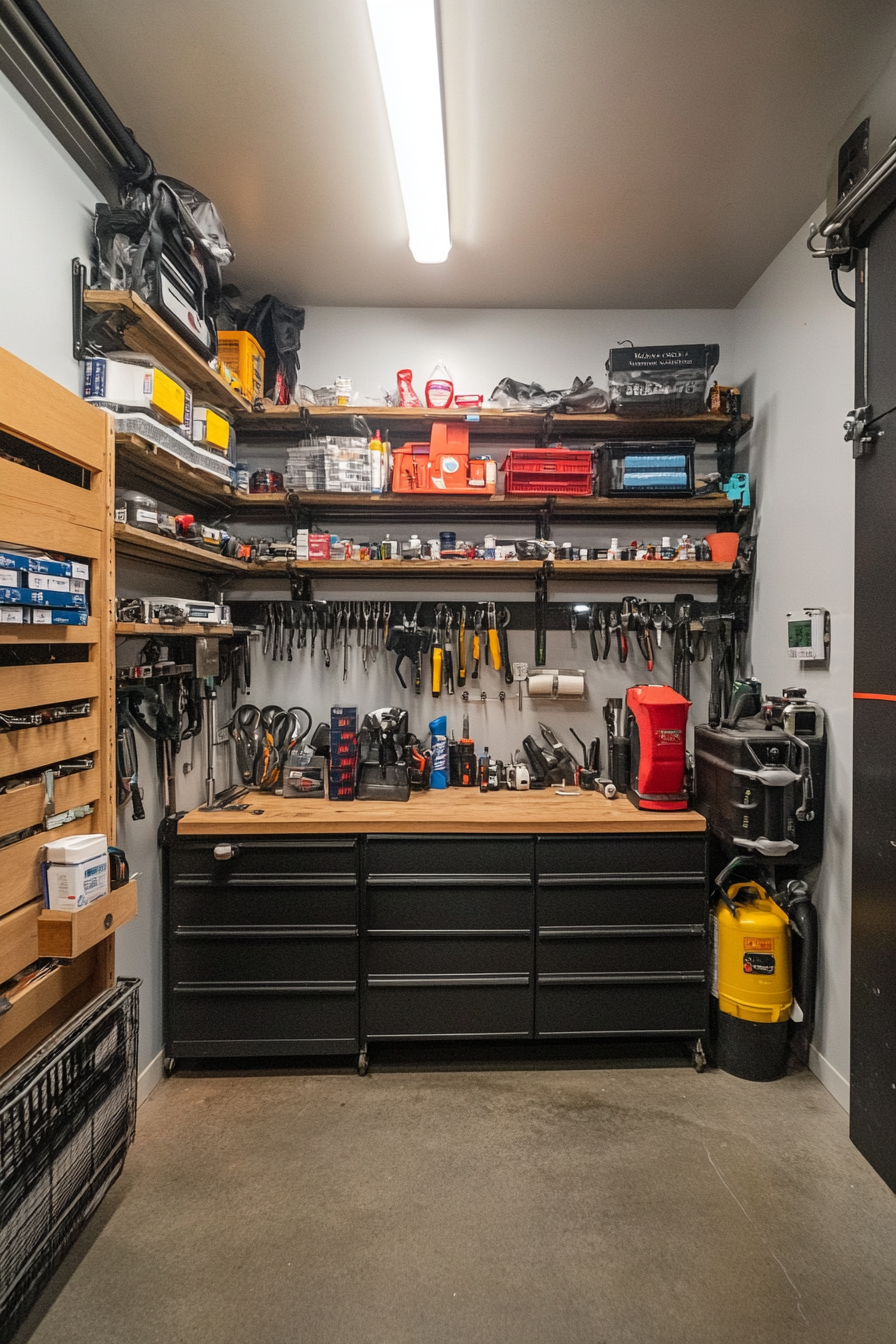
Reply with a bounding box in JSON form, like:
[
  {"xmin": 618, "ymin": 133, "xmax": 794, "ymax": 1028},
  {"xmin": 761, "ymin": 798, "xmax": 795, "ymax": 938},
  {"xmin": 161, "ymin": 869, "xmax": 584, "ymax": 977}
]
[{"xmin": 850, "ymin": 198, "xmax": 896, "ymax": 1189}]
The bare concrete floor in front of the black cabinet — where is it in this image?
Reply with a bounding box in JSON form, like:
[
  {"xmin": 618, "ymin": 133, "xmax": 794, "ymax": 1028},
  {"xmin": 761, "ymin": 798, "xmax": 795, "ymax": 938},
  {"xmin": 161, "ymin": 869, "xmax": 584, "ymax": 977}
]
[{"xmin": 10, "ymin": 1067, "xmax": 896, "ymax": 1344}]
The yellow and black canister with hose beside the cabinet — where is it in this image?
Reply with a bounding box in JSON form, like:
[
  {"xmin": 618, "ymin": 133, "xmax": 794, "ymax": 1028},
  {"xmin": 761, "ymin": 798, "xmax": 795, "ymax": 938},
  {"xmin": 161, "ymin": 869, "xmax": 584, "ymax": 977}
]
[{"xmin": 711, "ymin": 857, "xmax": 818, "ymax": 1082}]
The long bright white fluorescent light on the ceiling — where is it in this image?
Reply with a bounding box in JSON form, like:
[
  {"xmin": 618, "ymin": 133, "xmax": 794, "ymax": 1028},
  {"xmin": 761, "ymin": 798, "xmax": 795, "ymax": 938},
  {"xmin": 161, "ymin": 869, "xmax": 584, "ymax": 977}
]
[{"xmin": 367, "ymin": 0, "xmax": 451, "ymax": 262}]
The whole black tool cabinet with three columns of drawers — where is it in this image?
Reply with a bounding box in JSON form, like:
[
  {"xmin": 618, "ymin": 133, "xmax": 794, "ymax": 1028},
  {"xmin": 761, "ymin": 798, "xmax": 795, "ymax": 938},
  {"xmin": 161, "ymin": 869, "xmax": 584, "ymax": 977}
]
[{"xmin": 165, "ymin": 833, "xmax": 708, "ymax": 1071}]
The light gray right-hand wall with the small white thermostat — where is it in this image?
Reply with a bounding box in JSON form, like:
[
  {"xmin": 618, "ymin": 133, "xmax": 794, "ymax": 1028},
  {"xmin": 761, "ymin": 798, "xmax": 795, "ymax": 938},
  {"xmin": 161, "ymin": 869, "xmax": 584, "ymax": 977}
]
[{"xmin": 735, "ymin": 208, "xmax": 854, "ymax": 1106}]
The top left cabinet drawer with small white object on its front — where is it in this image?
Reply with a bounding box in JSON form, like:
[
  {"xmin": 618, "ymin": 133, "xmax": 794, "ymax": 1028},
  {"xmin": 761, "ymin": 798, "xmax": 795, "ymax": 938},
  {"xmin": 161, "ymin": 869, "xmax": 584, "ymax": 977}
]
[{"xmin": 172, "ymin": 836, "xmax": 359, "ymax": 884}]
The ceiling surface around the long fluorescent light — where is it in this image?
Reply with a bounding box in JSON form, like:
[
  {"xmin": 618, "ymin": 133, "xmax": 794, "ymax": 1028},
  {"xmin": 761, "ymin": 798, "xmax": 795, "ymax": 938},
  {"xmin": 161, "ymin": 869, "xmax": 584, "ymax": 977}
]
[{"xmin": 43, "ymin": 0, "xmax": 896, "ymax": 308}]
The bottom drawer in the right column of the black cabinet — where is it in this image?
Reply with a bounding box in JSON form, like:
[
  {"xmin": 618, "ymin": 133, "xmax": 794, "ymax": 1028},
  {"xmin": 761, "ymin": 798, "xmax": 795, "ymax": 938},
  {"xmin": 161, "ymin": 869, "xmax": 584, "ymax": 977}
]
[{"xmin": 535, "ymin": 973, "xmax": 708, "ymax": 1036}]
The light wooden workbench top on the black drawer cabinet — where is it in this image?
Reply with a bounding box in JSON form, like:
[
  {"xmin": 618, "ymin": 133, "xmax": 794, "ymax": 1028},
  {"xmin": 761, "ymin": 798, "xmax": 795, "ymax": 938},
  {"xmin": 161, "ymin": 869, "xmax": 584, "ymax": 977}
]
[{"xmin": 177, "ymin": 789, "xmax": 707, "ymax": 836}]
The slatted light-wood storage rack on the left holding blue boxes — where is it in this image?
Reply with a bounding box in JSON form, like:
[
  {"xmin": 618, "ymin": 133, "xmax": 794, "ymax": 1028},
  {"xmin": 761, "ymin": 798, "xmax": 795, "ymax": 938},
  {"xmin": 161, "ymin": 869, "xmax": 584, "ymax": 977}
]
[{"xmin": 0, "ymin": 351, "xmax": 136, "ymax": 1074}]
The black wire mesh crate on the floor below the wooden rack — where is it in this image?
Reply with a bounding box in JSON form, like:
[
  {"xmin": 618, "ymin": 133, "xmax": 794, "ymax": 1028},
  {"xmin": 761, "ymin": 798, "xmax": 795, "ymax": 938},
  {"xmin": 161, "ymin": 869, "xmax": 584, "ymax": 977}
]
[{"xmin": 0, "ymin": 980, "xmax": 140, "ymax": 1344}]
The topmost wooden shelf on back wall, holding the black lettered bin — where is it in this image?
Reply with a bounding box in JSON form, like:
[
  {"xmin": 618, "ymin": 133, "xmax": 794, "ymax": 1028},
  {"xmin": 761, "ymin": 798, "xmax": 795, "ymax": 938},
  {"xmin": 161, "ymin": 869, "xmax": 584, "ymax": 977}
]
[{"xmin": 233, "ymin": 406, "xmax": 752, "ymax": 444}]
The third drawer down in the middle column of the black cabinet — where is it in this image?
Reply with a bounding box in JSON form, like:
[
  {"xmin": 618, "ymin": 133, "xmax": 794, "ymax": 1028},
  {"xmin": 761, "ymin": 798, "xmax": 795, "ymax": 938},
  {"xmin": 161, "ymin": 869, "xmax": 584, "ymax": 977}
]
[{"xmin": 367, "ymin": 930, "xmax": 532, "ymax": 976}]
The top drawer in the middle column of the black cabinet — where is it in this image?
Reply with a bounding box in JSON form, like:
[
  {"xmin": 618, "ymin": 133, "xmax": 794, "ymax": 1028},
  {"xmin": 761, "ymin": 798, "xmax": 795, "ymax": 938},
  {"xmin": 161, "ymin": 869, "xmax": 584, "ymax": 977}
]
[{"xmin": 367, "ymin": 835, "xmax": 533, "ymax": 878}]
